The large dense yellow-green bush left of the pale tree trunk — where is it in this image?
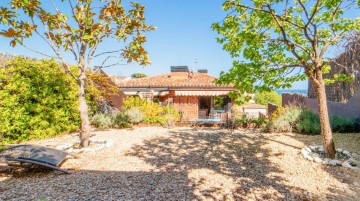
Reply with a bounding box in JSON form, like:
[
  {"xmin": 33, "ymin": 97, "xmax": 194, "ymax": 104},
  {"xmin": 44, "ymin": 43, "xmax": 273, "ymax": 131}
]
[{"xmin": 0, "ymin": 58, "xmax": 80, "ymax": 143}]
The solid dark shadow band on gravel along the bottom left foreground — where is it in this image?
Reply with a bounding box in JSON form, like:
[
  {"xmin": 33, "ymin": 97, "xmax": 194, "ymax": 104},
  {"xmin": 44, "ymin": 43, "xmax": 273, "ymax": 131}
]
[{"xmin": 0, "ymin": 170, "xmax": 195, "ymax": 200}]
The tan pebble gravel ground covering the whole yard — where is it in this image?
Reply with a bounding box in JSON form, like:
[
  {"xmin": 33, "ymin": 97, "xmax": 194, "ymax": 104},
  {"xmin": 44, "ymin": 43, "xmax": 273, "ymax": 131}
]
[{"xmin": 0, "ymin": 127, "xmax": 360, "ymax": 200}]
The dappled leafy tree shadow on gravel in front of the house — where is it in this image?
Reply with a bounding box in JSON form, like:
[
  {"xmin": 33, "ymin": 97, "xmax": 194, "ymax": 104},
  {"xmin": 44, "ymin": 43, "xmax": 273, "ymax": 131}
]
[{"xmin": 127, "ymin": 128, "xmax": 308, "ymax": 200}]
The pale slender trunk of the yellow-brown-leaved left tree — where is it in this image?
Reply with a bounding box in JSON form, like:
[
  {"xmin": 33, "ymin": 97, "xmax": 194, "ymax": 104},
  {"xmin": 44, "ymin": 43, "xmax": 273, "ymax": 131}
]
[{"xmin": 77, "ymin": 67, "xmax": 90, "ymax": 147}]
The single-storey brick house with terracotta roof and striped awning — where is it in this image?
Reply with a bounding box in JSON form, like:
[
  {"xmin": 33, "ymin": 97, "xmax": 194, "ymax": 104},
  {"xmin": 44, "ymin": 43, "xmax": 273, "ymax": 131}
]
[{"xmin": 117, "ymin": 66, "xmax": 234, "ymax": 121}]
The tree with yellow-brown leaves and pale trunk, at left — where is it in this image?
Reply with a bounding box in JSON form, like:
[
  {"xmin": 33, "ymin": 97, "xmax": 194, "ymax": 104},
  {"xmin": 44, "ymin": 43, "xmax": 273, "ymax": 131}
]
[{"xmin": 0, "ymin": 0, "xmax": 154, "ymax": 147}]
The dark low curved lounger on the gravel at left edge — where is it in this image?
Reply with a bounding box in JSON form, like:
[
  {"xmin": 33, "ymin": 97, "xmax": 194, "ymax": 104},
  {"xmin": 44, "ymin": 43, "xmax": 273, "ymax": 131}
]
[{"xmin": 0, "ymin": 144, "xmax": 71, "ymax": 174}]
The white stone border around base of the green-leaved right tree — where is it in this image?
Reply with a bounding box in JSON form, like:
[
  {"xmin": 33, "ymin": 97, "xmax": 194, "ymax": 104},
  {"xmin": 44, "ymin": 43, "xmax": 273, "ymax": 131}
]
[{"xmin": 301, "ymin": 145, "xmax": 360, "ymax": 170}]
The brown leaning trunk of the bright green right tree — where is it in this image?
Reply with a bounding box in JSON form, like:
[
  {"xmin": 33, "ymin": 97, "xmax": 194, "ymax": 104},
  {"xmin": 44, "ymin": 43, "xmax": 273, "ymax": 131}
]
[{"xmin": 314, "ymin": 70, "xmax": 336, "ymax": 158}]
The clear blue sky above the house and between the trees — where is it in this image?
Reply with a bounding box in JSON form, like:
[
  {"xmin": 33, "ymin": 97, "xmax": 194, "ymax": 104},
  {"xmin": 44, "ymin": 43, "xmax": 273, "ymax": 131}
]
[{"xmin": 0, "ymin": 0, "xmax": 358, "ymax": 89}]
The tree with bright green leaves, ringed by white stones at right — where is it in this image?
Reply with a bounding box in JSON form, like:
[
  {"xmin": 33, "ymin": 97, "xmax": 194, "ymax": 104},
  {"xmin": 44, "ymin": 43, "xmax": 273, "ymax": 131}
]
[{"xmin": 212, "ymin": 0, "xmax": 360, "ymax": 158}]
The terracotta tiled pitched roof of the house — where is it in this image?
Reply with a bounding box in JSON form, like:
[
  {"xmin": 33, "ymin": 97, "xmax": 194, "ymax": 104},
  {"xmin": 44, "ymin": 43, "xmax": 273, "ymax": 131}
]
[{"xmin": 117, "ymin": 72, "xmax": 230, "ymax": 88}]
